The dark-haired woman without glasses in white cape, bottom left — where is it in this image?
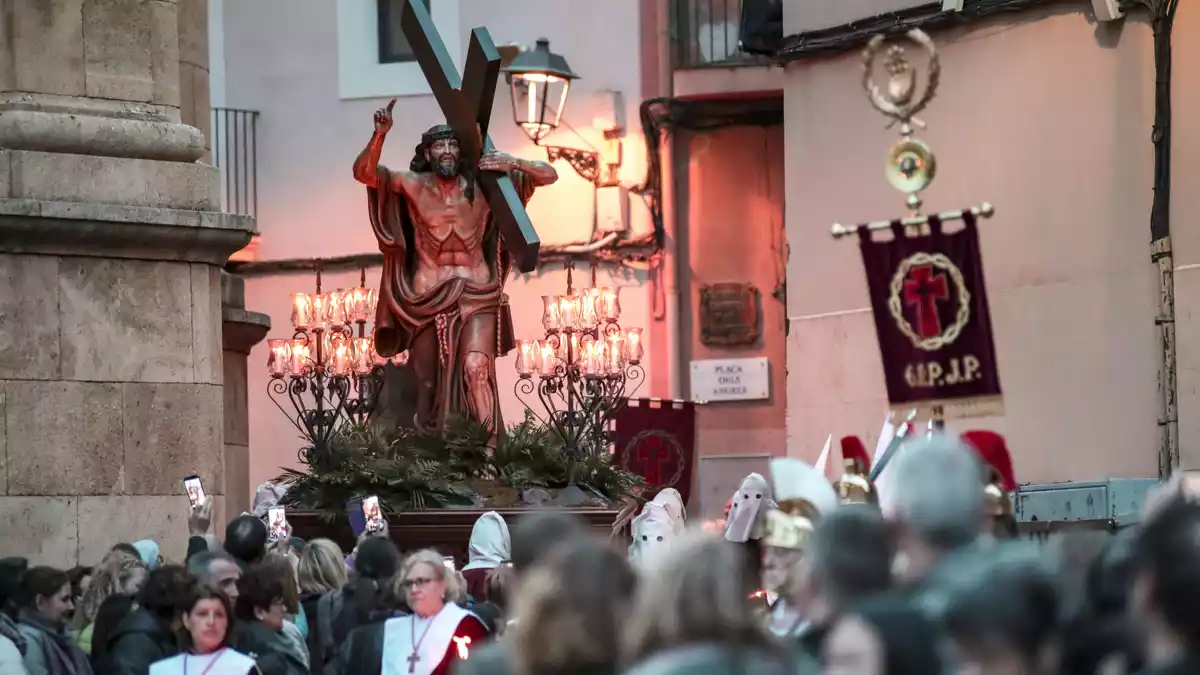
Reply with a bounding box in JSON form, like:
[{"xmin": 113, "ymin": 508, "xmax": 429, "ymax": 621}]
[{"xmin": 150, "ymin": 586, "xmax": 259, "ymax": 675}]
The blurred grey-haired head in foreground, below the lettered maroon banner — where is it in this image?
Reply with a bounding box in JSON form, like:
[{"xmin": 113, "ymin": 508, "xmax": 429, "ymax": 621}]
[{"xmin": 888, "ymin": 435, "xmax": 985, "ymax": 550}]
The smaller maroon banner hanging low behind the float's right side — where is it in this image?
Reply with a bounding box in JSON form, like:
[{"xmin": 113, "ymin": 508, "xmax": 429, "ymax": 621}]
[{"xmin": 614, "ymin": 399, "xmax": 696, "ymax": 503}]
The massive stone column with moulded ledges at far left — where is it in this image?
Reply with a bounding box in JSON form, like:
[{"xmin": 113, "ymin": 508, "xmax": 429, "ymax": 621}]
[{"xmin": 0, "ymin": 0, "xmax": 254, "ymax": 566}]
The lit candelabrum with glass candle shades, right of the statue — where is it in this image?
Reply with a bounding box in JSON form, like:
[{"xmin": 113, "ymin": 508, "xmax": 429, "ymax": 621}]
[{"xmin": 515, "ymin": 267, "xmax": 646, "ymax": 504}]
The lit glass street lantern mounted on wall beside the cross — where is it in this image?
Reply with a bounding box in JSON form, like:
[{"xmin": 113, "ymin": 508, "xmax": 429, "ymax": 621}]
[{"xmin": 503, "ymin": 37, "xmax": 580, "ymax": 144}]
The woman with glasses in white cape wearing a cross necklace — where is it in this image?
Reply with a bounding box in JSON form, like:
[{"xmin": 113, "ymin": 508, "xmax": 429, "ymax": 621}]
[{"xmin": 326, "ymin": 550, "xmax": 487, "ymax": 675}]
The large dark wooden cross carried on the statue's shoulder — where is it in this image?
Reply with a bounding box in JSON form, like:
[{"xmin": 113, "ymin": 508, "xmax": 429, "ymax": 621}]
[{"xmin": 400, "ymin": 0, "xmax": 541, "ymax": 271}]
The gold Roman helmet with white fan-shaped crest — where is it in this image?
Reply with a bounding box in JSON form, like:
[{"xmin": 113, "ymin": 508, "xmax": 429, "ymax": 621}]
[{"xmin": 762, "ymin": 459, "xmax": 838, "ymax": 550}]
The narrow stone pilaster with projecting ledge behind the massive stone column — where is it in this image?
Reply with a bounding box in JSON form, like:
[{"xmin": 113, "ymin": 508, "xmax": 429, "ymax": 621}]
[{"xmin": 221, "ymin": 273, "xmax": 271, "ymax": 514}]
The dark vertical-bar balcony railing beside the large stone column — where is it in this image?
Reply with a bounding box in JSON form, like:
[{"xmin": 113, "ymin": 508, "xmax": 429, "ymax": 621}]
[{"xmin": 212, "ymin": 108, "xmax": 258, "ymax": 217}]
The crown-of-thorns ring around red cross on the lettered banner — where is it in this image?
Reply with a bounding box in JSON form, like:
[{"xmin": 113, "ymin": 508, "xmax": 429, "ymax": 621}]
[{"xmin": 888, "ymin": 252, "xmax": 971, "ymax": 352}]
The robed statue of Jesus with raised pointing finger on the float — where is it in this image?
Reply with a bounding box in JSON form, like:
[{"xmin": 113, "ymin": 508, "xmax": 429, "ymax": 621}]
[{"xmin": 354, "ymin": 100, "xmax": 558, "ymax": 438}]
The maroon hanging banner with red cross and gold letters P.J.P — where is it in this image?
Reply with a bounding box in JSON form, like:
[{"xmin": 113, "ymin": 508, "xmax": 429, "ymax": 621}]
[{"xmin": 858, "ymin": 213, "xmax": 1001, "ymax": 406}]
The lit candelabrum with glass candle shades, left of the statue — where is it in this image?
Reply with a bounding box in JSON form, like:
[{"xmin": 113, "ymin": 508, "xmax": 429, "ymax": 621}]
[{"xmin": 266, "ymin": 269, "xmax": 408, "ymax": 465}]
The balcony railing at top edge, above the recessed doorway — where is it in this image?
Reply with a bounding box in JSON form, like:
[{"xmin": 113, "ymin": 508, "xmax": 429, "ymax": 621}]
[{"xmin": 671, "ymin": 0, "xmax": 764, "ymax": 68}]
